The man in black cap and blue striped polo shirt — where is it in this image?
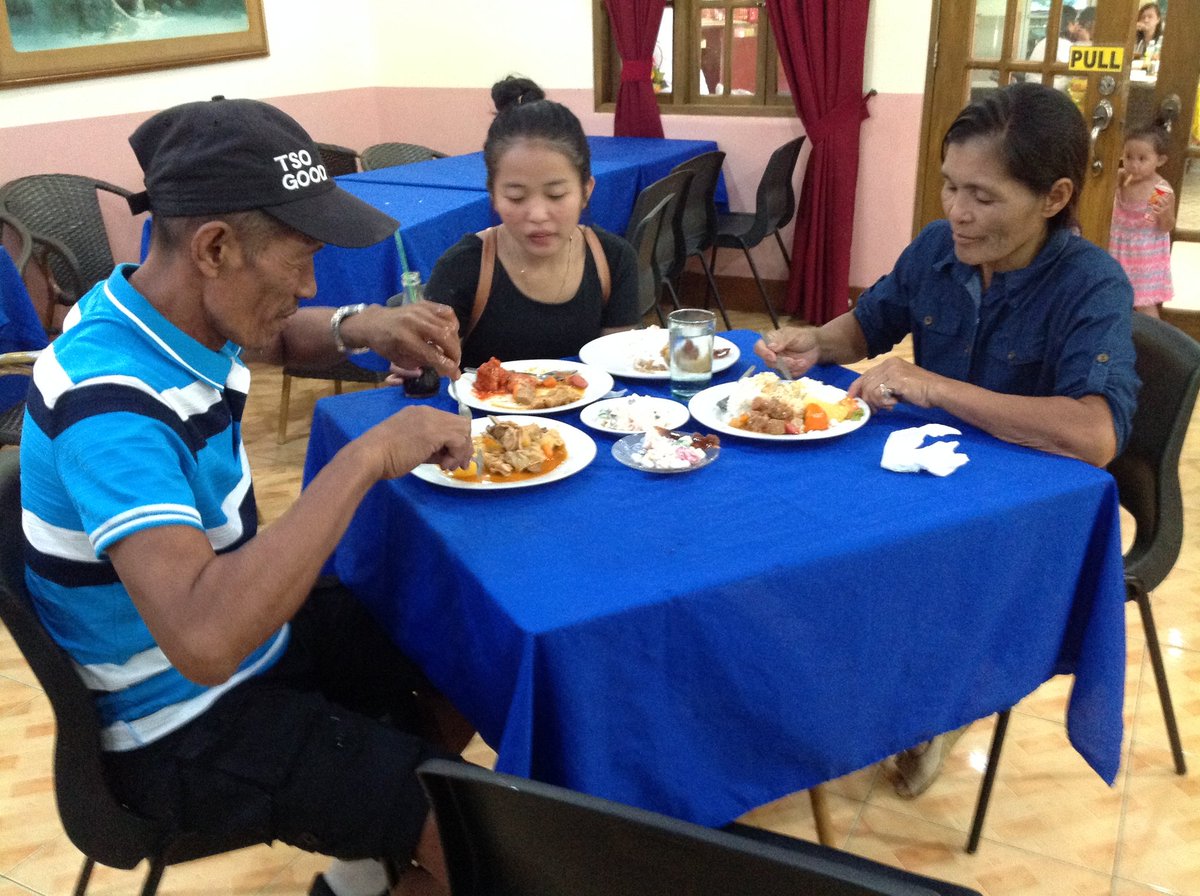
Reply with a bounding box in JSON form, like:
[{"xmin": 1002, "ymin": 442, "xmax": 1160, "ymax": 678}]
[{"xmin": 22, "ymin": 98, "xmax": 472, "ymax": 891}]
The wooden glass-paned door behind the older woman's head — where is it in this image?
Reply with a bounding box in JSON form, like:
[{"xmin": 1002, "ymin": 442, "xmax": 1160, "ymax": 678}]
[{"xmin": 914, "ymin": 0, "xmax": 1142, "ymax": 246}]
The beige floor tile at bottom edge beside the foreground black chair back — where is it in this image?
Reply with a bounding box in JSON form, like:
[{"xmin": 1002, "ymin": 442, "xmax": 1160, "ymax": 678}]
[{"xmin": 846, "ymin": 806, "xmax": 1111, "ymax": 896}]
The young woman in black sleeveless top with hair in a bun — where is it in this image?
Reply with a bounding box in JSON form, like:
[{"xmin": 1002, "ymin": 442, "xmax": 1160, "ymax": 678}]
[{"xmin": 426, "ymin": 77, "xmax": 637, "ymax": 367}]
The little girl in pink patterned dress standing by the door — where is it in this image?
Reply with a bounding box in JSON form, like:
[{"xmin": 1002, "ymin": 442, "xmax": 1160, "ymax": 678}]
[{"xmin": 1109, "ymin": 125, "xmax": 1175, "ymax": 318}]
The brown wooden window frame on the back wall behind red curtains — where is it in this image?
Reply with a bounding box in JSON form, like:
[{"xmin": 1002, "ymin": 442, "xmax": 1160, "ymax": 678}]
[{"xmin": 592, "ymin": 0, "xmax": 796, "ymax": 118}]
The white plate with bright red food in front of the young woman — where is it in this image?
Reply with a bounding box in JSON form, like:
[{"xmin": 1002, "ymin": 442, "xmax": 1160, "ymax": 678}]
[{"xmin": 454, "ymin": 357, "xmax": 612, "ymax": 414}]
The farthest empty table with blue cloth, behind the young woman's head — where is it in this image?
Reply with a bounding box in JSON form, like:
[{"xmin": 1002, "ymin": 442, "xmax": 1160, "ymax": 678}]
[{"xmin": 338, "ymin": 137, "xmax": 726, "ymax": 234}]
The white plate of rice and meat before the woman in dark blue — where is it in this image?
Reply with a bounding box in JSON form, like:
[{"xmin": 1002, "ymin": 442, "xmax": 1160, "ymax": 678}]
[{"xmin": 688, "ymin": 372, "xmax": 871, "ymax": 441}]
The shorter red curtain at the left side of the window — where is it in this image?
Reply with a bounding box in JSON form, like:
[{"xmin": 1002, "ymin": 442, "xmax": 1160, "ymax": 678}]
[{"xmin": 605, "ymin": 0, "xmax": 666, "ymax": 137}]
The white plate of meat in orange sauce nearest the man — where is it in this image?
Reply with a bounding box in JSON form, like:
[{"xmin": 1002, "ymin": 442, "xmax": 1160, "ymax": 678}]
[{"xmin": 413, "ymin": 415, "xmax": 596, "ymax": 492}]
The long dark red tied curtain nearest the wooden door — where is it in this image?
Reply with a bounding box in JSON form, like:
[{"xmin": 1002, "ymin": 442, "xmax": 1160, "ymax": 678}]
[{"xmin": 767, "ymin": 0, "xmax": 874, "ymax": 324}]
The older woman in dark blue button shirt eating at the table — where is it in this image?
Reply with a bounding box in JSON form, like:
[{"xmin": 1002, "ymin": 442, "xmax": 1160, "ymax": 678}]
[{"xmin": 755, "ymin": 83, "xmax": 1140, "ymax": 798}]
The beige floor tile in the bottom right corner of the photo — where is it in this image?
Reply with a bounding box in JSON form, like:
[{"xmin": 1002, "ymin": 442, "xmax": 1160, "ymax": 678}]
[{"xmin": 1116, "ymin": 744, "xmax": 1200, "ymax": 896}]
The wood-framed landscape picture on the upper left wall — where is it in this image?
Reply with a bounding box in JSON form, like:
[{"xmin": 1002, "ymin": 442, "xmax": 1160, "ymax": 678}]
[{"xmin": 0, "ymin": 0, "xmax": 268, "ymax": 88}]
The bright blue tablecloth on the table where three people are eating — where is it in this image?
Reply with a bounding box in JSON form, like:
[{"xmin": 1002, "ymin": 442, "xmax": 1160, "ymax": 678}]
[{"xmin": 305, "ymin": 331, "xmax": 1126, "ymax": 825}]
